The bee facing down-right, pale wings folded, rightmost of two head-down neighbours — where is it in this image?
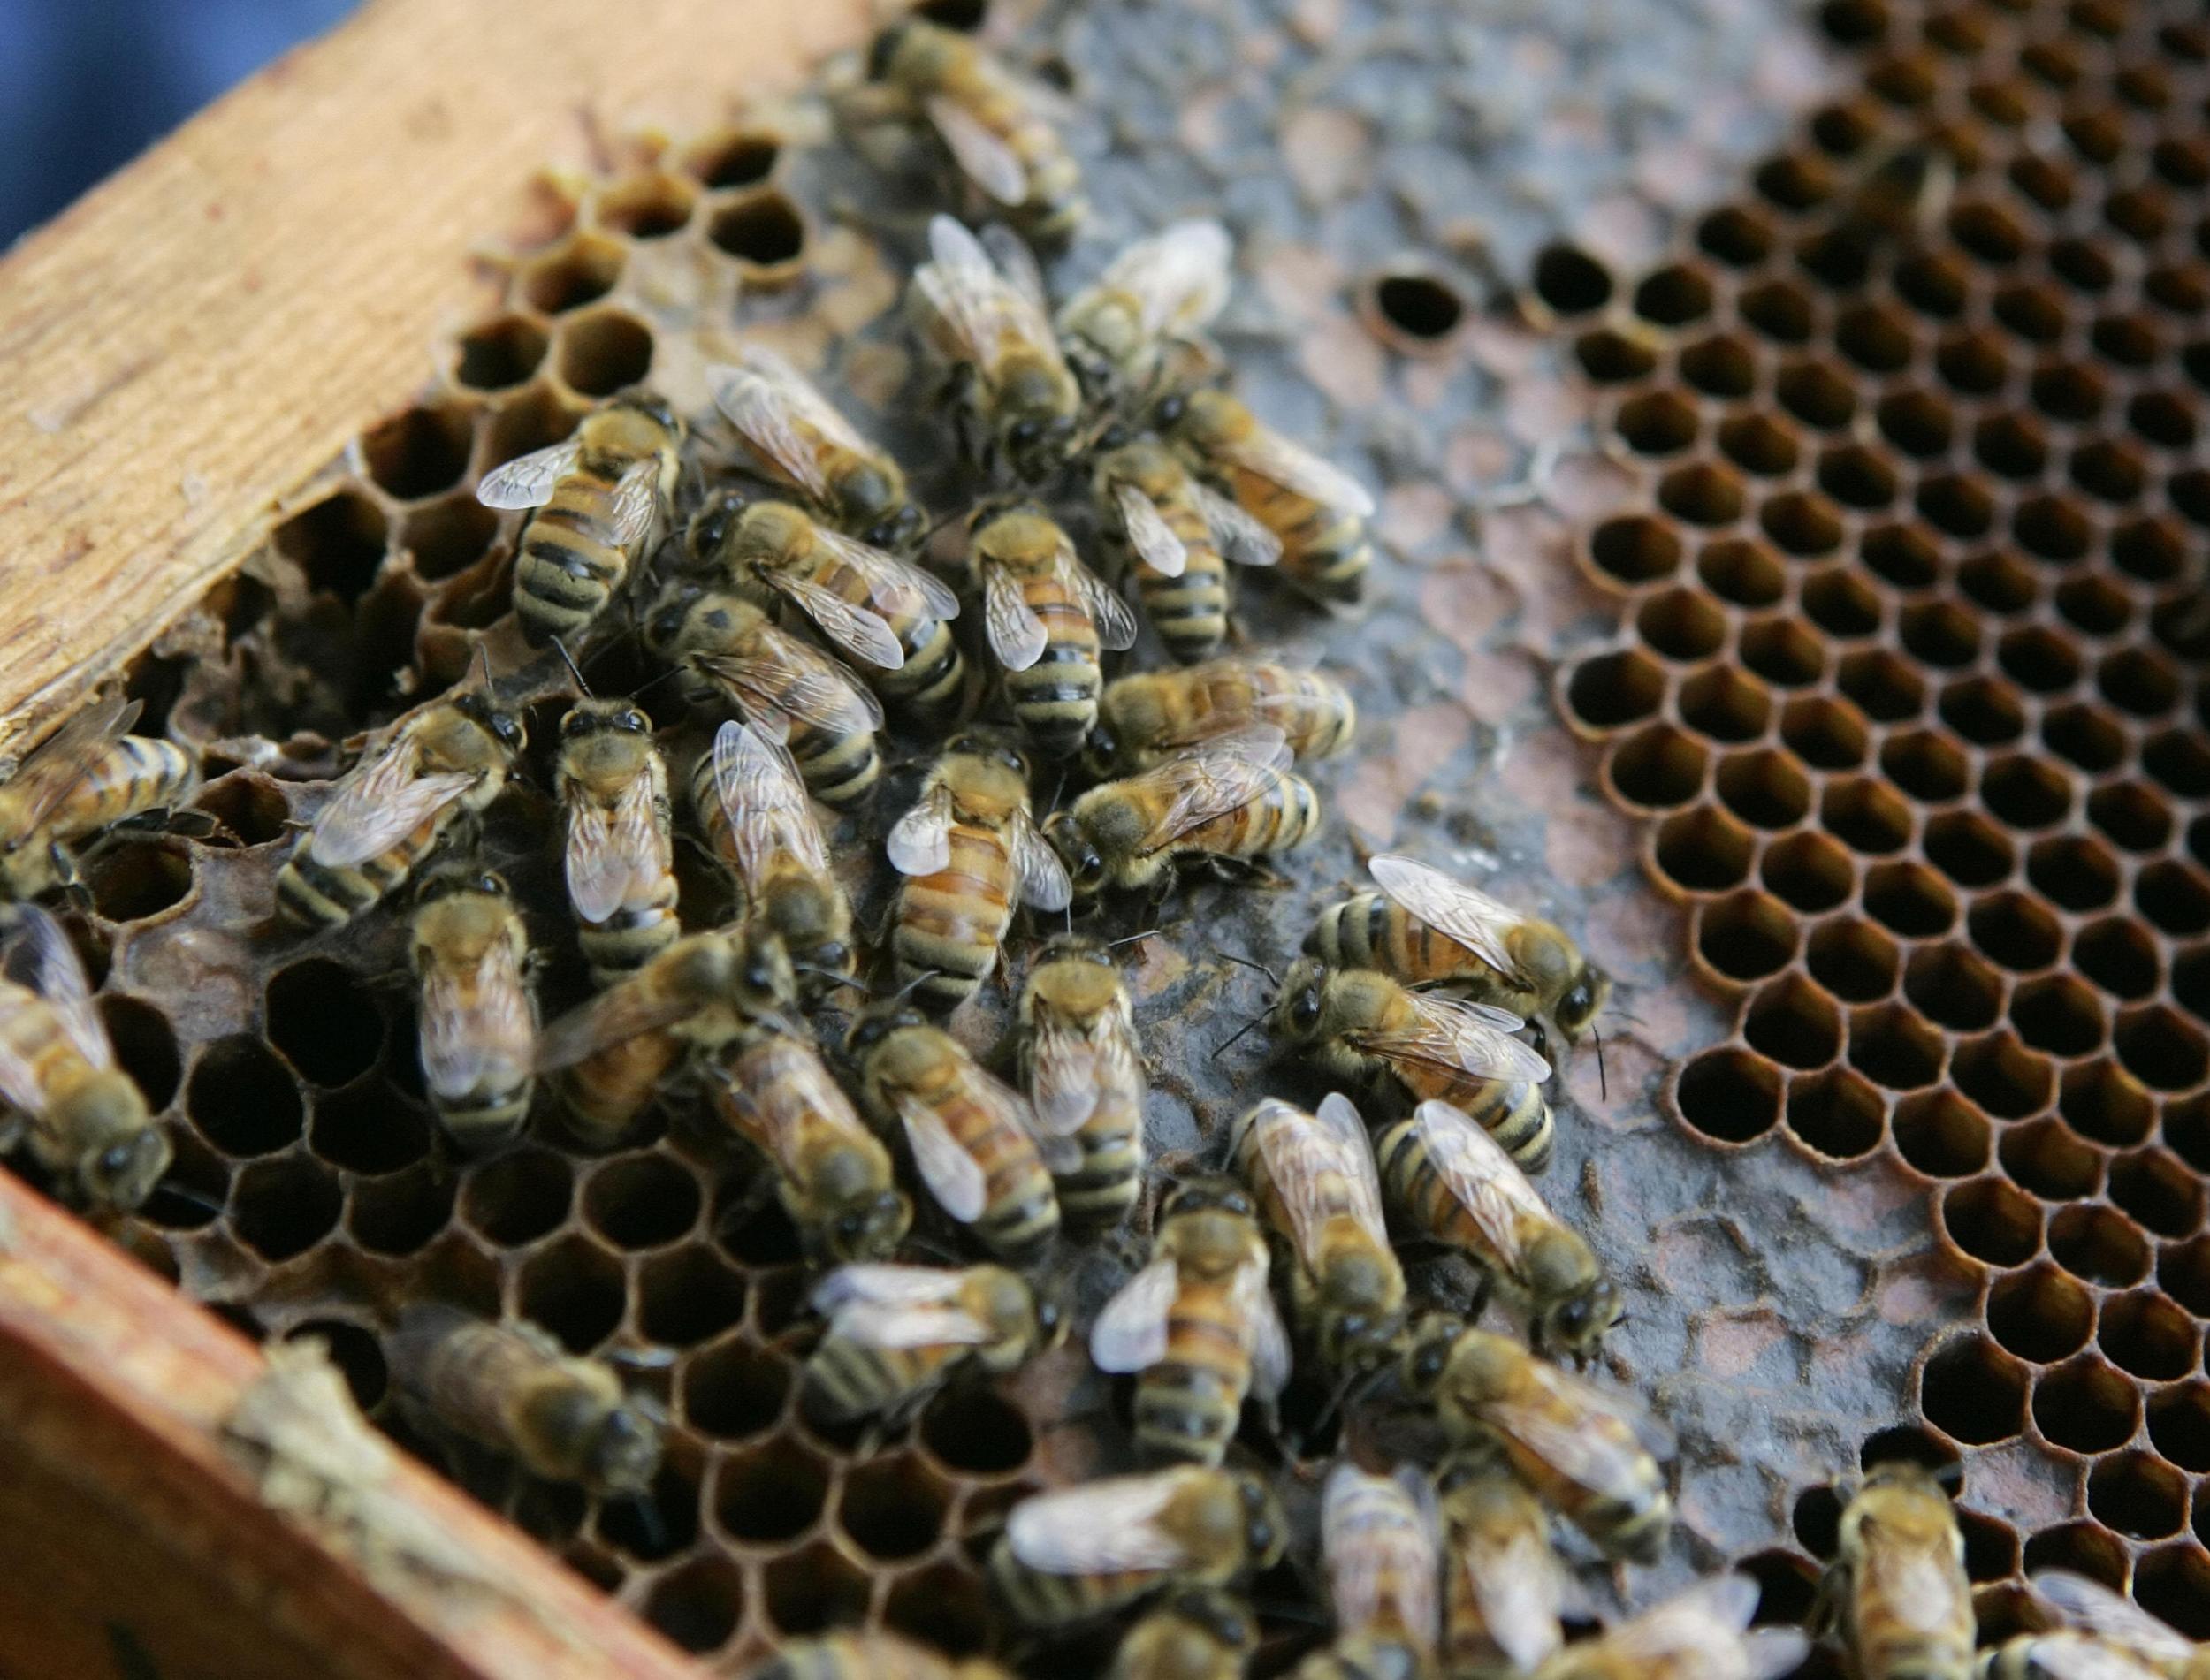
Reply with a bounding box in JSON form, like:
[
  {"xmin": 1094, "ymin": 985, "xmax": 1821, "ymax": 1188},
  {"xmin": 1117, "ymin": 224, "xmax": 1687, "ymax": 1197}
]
[{"xmin": 1375, "ymin": 1103, "xmax": 1625, "ymax": 1362}]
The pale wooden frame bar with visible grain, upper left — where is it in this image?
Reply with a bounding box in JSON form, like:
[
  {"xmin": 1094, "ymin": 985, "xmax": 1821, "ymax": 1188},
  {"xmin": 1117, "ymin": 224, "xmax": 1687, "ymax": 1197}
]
[{"xmin": 0, "ymin": 0, "xmax": 869, "ymax": 749}]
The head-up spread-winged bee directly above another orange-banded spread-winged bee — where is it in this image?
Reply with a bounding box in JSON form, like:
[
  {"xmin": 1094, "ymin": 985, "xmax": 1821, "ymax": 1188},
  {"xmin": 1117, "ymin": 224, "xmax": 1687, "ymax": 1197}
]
[{"xmin": 968, "ymin": 508, "xmax": 1136, "ymax": 758}]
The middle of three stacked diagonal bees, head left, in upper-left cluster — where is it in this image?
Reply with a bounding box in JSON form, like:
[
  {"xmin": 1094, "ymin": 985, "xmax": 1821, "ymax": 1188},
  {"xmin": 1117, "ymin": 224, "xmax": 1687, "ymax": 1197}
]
[{"xmin": 685, "ymin": 490, "xmax": 966, "ymax": 716}]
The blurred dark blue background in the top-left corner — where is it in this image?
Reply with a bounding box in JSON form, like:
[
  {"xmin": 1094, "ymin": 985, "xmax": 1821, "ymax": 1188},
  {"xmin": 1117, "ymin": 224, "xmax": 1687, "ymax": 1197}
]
[{"xmin": 0, "ymin": 0, "xmax": 358, "ymax": 247}]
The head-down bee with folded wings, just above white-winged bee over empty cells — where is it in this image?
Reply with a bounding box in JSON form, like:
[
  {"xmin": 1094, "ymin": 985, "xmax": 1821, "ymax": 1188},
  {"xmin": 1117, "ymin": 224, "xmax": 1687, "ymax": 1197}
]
[{"xmin": 707, "ymin": 1019, "xmax": 913, "ymax": 1262}]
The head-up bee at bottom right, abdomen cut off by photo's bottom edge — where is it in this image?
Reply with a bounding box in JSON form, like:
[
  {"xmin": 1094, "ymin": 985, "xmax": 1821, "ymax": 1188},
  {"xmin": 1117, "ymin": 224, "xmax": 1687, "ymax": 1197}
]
[{"xmin": 1828, "ymin": 1461, "xmax": 1978, "ymax": 1680}]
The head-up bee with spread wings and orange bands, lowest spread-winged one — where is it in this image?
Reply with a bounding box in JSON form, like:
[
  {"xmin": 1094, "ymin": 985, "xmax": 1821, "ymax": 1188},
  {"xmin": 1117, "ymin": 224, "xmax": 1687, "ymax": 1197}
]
[{"xmin": 1090, "ymin": 1178, "xmax": 1289, "ymax": 1463}]
